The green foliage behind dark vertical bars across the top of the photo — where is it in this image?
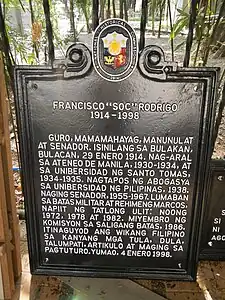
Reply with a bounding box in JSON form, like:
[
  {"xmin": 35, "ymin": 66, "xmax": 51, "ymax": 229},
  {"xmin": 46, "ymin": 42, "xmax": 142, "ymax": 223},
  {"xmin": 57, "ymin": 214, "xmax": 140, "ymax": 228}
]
[{"xmin": 1, "ymin": 0, "xmax": 225, "ymax": 65}]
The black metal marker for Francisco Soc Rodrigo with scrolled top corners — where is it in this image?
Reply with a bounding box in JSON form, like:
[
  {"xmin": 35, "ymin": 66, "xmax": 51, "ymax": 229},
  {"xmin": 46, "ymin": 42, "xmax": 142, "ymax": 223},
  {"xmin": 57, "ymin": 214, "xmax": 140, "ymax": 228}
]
[{"xmin": 16, "ymin": 41, "xmax": 217, "ymax": 280}]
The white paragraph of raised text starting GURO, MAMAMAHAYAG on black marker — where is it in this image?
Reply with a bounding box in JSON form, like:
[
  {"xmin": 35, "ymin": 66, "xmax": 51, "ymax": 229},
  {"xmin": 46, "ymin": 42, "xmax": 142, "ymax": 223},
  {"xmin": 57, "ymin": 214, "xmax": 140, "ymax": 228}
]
[{"xmin": 38, "ymin": 134, "xmax": 193, "ymax": 258}]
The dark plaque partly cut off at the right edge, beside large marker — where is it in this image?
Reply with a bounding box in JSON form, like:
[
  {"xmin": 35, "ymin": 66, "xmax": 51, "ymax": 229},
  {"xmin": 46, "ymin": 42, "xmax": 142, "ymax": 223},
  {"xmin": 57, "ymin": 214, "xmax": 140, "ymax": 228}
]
[{"xmin": 200, "ymin": 160, "xmax": 225, "ymax": 260}]
